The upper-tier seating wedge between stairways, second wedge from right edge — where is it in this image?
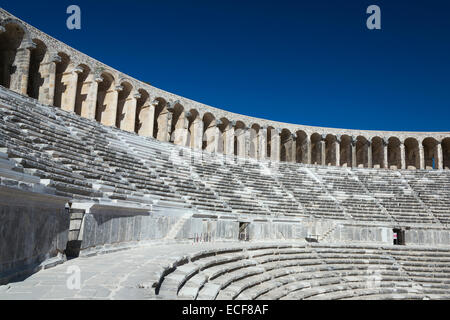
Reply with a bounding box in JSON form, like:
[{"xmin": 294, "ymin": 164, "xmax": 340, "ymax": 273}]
[{"xmin": 354, "ymin": 169, "xmax": 435, "ymax": 223}]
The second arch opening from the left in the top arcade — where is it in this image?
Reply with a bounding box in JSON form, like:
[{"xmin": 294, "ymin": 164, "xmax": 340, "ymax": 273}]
[{"xmin": 27, "ymin": 39, "xmax": 49, "ymax": 102}]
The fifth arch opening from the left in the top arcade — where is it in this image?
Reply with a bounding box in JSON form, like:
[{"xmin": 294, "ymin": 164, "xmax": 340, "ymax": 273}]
[{"xmin": 95, "ymin": 72, "xmax": 117, "ymax": 125}]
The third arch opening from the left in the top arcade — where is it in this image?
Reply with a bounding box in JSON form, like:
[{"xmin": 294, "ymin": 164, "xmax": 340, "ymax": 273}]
[{"xmin": 53, "ymin": 52, "xmax": 71, "ymax": 110}]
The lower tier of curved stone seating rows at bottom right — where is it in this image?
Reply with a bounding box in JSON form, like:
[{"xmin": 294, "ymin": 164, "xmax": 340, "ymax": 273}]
[{"xmin": 157, "ymin": 244, "xmax": 450, "ymax": 300}]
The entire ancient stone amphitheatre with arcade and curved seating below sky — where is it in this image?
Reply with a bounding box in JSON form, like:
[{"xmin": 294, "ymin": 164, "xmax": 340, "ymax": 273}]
[{"xmin": 0, "ymin": 10, "xmax": 450, "ymax": 300}]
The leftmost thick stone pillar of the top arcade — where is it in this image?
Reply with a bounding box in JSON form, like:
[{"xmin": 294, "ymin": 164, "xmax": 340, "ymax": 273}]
[{"xmin": 9, "ymin": 42, "xmax": 36, "ymax": 96}]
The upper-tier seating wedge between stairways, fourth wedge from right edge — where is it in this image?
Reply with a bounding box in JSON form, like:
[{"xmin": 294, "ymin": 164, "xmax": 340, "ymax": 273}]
[{"xmin": 272, "ymin": 163, "xmax": 346, "ymax": 219}]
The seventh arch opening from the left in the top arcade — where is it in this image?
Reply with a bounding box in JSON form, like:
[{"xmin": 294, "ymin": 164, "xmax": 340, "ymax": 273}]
[{"xmin": 134, "ymin": 89, "xmax": 155, "ymax": 137}]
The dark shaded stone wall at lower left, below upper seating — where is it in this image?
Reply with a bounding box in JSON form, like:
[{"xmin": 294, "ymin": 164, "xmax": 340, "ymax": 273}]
[{"xmin": 0, "ymin": 186, "xmax": 69, "ymax": 284}]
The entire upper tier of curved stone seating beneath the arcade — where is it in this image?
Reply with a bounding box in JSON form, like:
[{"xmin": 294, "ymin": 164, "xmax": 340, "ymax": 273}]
[{"xmin": 0, "ymin": 88, "xmax": 450, "ymax": 225}]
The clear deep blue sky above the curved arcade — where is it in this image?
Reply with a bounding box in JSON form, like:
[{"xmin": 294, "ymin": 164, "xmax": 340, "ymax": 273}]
[{"xmin": 0, "ymin": 0, "xmax": 450, "ymax": 131}]
